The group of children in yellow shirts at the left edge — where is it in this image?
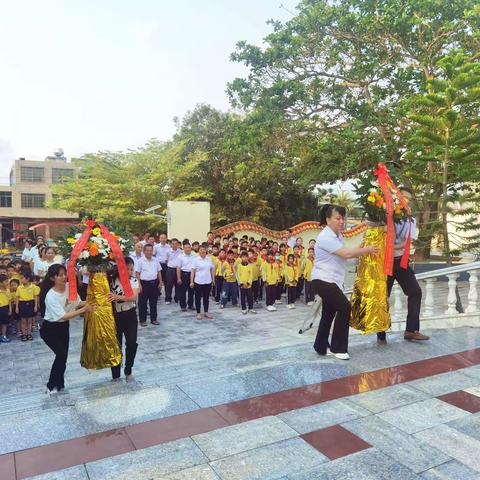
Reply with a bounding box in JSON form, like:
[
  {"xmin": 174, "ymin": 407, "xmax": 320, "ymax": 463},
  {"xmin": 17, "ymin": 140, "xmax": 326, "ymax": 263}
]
[{"xmin": 0, "ymin": 257, "xmax": 41, "ymax": 343}]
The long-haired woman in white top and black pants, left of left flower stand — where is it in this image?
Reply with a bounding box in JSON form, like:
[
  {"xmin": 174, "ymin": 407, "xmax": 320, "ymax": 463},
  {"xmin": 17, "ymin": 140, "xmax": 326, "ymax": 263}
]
[{"xmin": 39, "ymin": 264, "xmax": 95, "ymax": 394}]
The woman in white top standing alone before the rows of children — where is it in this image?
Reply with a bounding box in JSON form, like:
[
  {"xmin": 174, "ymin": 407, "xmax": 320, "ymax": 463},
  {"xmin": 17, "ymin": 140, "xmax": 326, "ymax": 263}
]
[{"xmin": 190, "ymin": 244, "xmax": 215, "ymax": 320}]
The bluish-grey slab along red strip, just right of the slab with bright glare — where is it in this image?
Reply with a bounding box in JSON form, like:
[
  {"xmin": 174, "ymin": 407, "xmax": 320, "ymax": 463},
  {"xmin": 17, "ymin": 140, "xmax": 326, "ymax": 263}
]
[{"xmin": 179, "ymin": 371, "xmax": 283, "ymax": 407}]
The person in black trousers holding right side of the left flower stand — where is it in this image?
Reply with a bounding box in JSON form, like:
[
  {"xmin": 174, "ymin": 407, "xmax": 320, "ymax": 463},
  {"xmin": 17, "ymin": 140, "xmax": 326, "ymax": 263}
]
[{"xmin": 109, "ymin": 257, "xmax": 139, "ymax": 382}]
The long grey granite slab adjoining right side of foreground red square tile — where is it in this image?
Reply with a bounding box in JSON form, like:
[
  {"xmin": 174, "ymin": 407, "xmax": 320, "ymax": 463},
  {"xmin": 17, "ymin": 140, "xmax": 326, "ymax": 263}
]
[{"xmin": 342, "ymin": 415, "xmax": 450, "ymax": 473}]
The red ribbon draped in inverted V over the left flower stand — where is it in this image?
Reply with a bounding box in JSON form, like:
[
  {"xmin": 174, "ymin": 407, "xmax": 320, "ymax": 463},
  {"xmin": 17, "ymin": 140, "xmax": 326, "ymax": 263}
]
[{"xmin": 67, "ymin": 220, "xmax": 133, "ymax": 301}]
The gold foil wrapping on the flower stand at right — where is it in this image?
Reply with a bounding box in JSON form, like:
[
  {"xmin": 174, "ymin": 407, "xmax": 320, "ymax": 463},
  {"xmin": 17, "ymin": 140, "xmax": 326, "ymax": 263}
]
[{"xmin": 350, "ymin": 227, "xmax": 391, "ymax": 333}]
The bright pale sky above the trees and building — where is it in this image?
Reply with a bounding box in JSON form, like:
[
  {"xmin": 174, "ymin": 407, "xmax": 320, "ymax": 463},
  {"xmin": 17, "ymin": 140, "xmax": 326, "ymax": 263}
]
[{"xmin": 0, "ymin": 0, "xmax": 298, "ymax": 183}]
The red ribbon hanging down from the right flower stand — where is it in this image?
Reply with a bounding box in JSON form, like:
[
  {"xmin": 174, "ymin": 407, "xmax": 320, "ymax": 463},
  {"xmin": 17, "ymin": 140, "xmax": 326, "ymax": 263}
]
[{"xmin": 373, "ymin": 163, "xmax": 412, "ymax": 275}]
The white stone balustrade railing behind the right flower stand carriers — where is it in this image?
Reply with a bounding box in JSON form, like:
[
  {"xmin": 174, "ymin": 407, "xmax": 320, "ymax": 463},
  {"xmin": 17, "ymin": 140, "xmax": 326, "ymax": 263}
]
[{"xmin": 299, "ymin": 262, "xmax": 480, "ymax": 334}]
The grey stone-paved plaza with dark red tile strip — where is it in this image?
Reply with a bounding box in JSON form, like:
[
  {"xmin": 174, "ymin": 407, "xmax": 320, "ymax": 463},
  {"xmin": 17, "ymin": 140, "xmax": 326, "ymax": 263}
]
[{"xmin": 0, "ymin": 301, "xmax": 480, "ymax": 480}]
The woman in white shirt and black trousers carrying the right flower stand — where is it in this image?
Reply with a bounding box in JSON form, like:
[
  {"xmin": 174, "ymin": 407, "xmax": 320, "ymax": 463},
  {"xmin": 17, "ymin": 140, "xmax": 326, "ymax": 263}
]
[{"xmin": 312, "ymin": 204, "xmax": 378, "ymax": 360}]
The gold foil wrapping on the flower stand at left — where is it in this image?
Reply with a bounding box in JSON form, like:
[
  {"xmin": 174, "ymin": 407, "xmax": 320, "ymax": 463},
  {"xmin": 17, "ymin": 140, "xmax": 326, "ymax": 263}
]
[{"xmin": 80, "ymin": 272, "xmax": 122, "ymax": 370}]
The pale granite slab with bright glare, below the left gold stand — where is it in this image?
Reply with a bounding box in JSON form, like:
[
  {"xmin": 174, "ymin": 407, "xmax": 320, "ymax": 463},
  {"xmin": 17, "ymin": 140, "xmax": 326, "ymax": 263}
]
[{"xmin": 75, "ymin": 386, "xmax": 198, "ymax": 432}]
